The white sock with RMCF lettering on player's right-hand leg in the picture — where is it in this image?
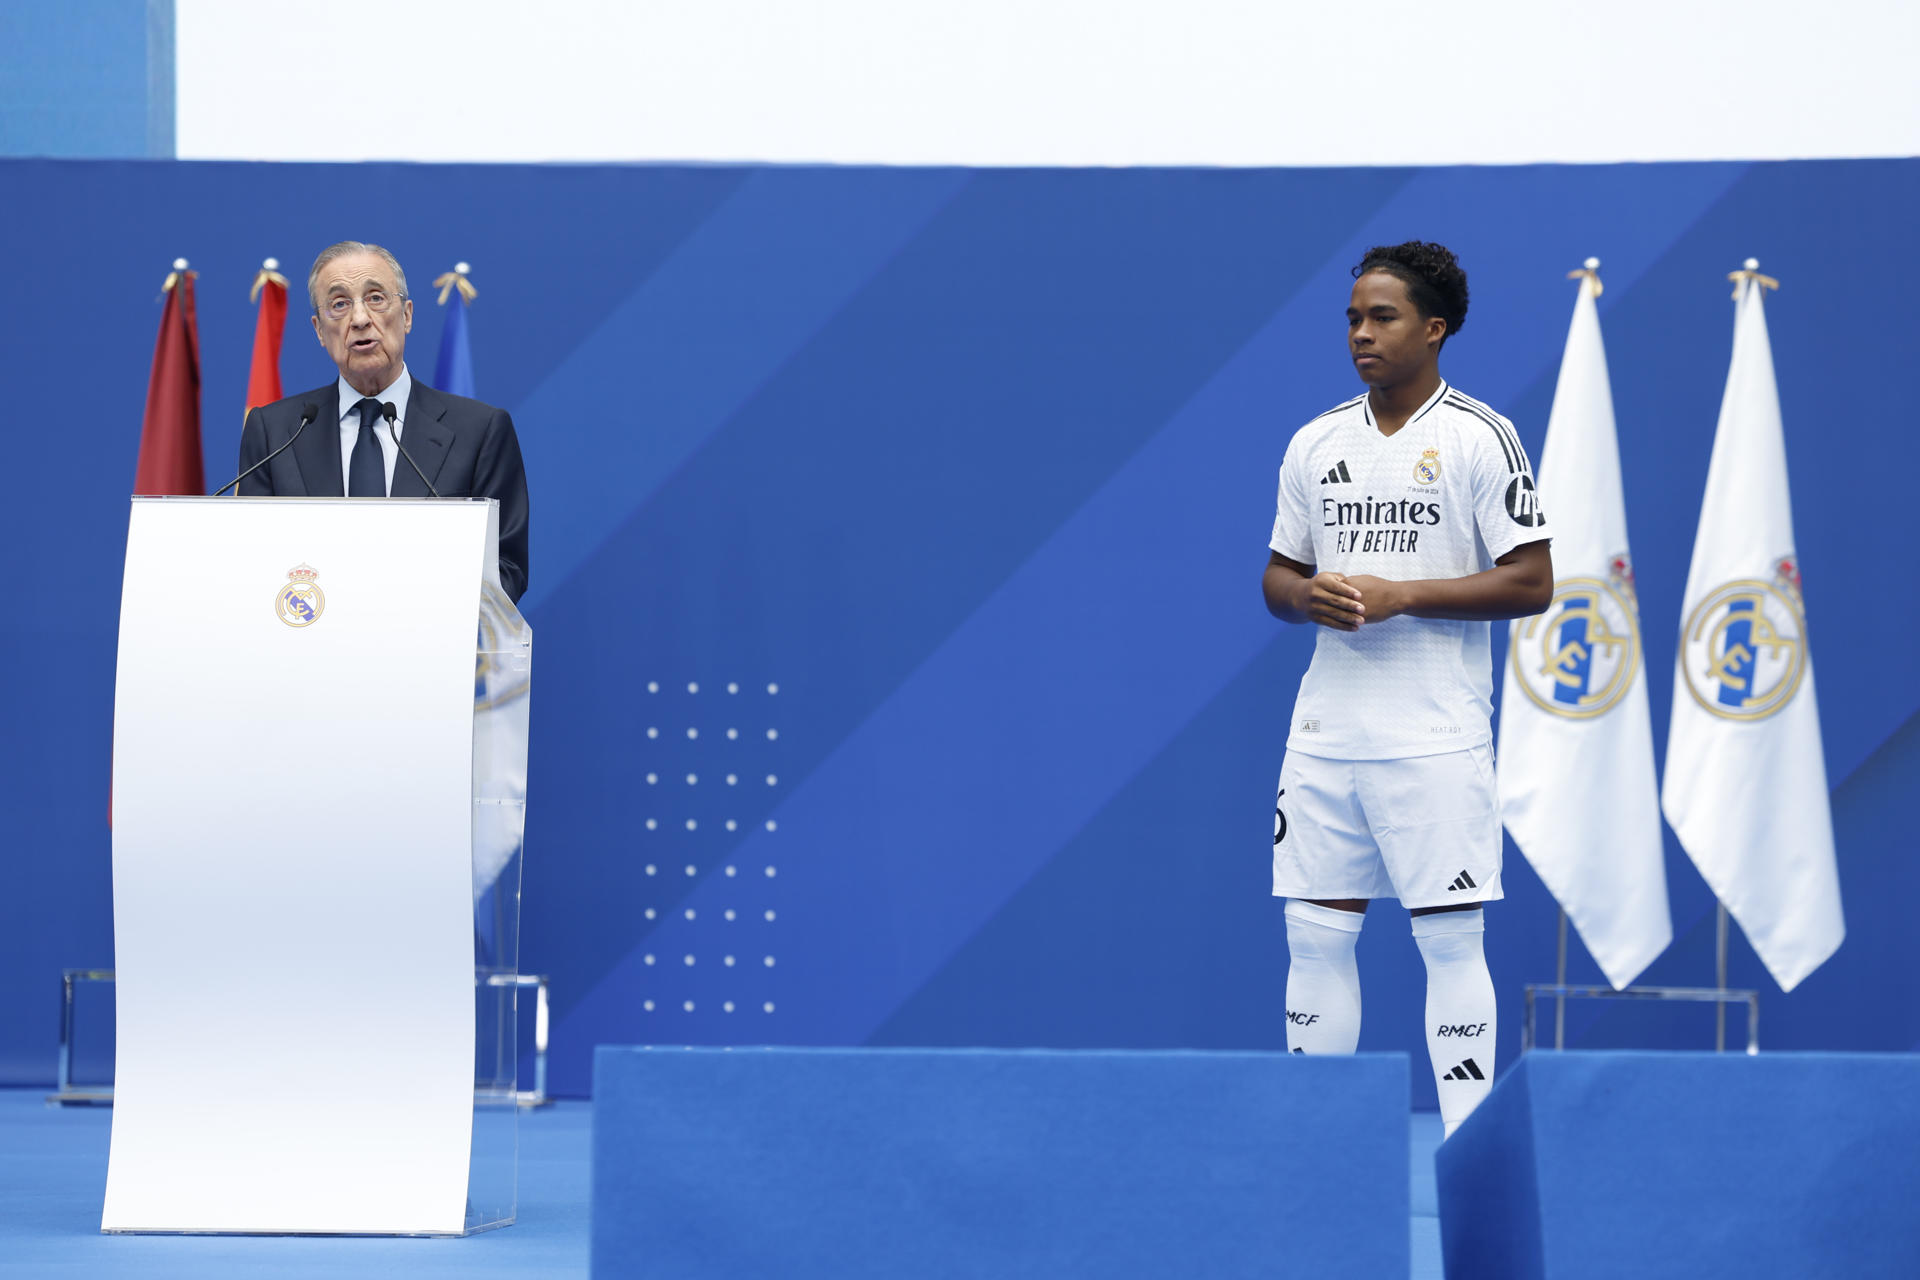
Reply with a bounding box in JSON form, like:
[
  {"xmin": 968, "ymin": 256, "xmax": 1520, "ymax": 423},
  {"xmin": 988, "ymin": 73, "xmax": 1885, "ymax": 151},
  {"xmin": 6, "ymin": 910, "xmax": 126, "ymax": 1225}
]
[{"xmin": 1413, "ymin": 910, "xmax": 1494, "ymax": 1138}]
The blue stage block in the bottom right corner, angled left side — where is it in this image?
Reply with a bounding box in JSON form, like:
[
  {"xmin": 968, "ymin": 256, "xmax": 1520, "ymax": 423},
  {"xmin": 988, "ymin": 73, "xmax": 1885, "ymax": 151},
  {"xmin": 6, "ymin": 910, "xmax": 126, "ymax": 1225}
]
[{"xmin": 1436, "ymin": 1052, "xmax": 1920, "ymax": 1280}]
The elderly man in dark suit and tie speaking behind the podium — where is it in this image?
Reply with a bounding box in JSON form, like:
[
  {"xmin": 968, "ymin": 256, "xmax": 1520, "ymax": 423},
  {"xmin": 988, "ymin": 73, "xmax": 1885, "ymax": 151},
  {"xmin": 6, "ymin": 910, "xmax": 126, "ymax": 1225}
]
[{"xmin": 240, "ymin": 240, "xmax": 526, "ymax": 603}]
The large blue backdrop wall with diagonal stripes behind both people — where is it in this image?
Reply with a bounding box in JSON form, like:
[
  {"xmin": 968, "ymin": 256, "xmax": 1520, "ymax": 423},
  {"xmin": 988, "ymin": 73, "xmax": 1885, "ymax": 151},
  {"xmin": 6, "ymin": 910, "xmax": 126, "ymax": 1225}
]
[{"xmin": 0, "ymin": 161, "xmax": 1920, "ymax": 1105}]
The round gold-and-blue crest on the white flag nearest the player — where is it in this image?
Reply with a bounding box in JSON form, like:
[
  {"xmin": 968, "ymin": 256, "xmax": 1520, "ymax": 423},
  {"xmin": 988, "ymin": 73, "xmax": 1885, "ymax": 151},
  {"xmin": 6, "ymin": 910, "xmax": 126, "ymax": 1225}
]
[{"xmin": 1509, "ymin": 551, "xmax": 1640, "ymax": 720}]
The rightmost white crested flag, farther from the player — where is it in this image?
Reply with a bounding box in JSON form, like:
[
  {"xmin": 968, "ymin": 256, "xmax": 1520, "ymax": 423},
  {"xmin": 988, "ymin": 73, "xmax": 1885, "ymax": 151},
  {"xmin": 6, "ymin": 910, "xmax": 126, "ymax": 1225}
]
[{"xmin": 1661, "ymin": 261, "xmax": 1847, "ymax": 990}]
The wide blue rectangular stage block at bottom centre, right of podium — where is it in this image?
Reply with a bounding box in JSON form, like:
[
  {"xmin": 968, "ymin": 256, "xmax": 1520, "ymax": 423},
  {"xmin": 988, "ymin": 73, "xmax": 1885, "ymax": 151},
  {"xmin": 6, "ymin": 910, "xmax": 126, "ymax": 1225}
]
[{"xmin": 593, "ymin": 1046, "xmax": 1407, "ymax": 1280}]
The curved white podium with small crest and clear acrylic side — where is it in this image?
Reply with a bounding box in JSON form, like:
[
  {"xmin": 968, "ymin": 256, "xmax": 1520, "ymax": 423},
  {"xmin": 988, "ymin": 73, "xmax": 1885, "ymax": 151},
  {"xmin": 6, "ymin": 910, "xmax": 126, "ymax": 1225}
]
[{"xmin": 102, "ymin": 497, "xmax": 532, "ymax": 1236}]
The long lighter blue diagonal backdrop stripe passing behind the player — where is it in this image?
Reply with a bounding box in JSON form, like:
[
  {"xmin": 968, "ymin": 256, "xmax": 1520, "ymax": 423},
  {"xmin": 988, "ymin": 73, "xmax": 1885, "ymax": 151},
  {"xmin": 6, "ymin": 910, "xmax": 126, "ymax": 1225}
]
[{"xmin": 560, "ymin": 165, "xmax": 1741, "ymax": 1044}]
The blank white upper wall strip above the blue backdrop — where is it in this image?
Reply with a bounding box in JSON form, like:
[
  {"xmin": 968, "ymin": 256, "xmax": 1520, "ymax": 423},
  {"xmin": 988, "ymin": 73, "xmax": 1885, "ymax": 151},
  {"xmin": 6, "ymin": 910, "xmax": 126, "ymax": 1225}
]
[{"xmin": 177, "ymin": 0, "xmax": 1920, "ymax": 165}]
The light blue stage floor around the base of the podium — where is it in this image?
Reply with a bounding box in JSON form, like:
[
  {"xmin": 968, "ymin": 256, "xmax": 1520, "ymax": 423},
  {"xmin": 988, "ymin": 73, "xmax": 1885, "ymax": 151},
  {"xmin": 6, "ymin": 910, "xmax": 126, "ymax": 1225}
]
[{"xmin": 0, "ymin": 1088, "xmax": 1442, "ymax": 1280}]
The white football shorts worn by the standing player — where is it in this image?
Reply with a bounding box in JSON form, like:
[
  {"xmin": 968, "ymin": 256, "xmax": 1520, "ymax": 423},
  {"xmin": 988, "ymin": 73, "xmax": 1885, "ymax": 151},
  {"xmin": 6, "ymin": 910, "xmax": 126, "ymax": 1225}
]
[{"xmin": 1273, "ymin": 745, "xmax": 1505, "ymax": 910}]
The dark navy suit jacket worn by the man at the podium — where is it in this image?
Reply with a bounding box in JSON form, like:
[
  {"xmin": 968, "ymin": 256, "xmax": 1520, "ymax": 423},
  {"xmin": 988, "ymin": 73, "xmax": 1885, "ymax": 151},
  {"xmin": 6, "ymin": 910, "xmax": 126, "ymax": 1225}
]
[{"xmin": 240, "ymin": 378, "xmax": 526, "ymax": 603}]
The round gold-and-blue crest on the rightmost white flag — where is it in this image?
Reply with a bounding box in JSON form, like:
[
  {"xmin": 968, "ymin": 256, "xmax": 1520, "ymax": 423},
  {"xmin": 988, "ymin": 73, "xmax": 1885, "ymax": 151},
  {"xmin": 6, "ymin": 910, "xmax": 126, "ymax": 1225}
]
[{"xmin": 1680, "ymin": 557, "xmax": 1807, "ymax": 720}]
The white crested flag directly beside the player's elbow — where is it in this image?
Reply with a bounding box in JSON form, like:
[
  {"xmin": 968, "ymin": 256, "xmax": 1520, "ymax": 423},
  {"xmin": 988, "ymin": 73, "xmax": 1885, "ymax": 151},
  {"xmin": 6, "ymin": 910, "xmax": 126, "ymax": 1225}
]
[{"xmin": 1500, "ymin": 263, "xmax": 1672, "ymax": 986}]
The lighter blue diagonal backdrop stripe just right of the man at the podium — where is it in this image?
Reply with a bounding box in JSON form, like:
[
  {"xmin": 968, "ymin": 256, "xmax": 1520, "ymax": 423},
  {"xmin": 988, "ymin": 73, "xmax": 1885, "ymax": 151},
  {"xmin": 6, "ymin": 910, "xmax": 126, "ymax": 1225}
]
[{"xmin": 520, "ymin": 169, "xmax": 970, "ymax": 604}]
